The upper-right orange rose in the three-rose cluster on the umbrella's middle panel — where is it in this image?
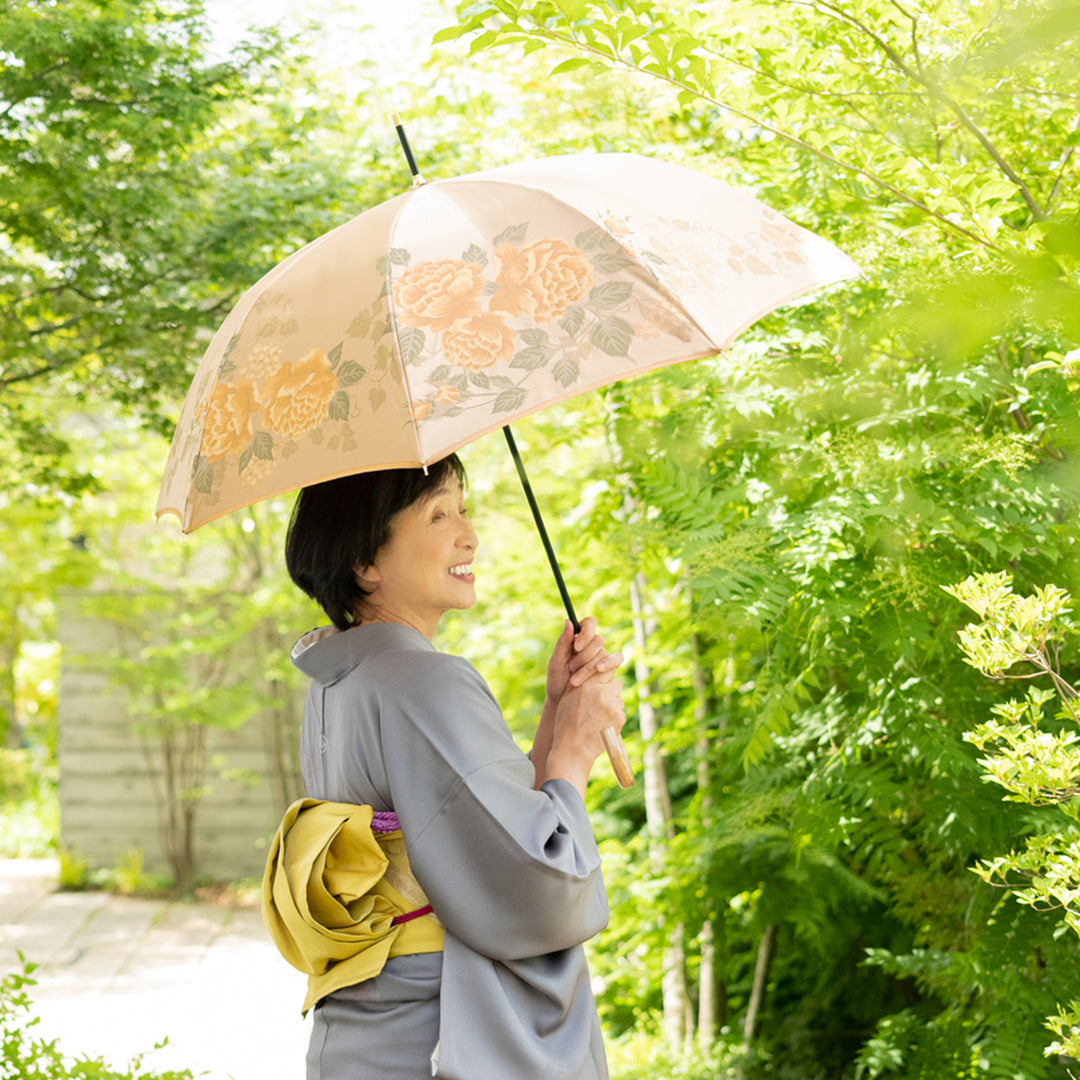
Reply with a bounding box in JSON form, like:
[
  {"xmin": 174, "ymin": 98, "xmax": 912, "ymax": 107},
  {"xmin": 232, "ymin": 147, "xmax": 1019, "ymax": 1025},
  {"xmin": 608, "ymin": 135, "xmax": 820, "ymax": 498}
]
[{"xmin": 490, "ymin": 243, "xmax": 593, "ymax": 323}]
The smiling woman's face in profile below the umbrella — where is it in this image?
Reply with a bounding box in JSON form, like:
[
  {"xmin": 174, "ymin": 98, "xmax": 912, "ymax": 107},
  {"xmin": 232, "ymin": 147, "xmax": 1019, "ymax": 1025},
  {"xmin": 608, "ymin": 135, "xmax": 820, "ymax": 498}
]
[{"xmin": 357, "ymin": 473, "xmax": 478, "ymax": 640}]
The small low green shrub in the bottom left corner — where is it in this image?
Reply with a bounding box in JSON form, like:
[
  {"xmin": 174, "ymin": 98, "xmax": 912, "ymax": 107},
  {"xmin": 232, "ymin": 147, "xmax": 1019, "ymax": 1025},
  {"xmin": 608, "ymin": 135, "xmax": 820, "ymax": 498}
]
[{"xmin": 0, "ymin": 954, "xmax": 194, "ymax": 1080}]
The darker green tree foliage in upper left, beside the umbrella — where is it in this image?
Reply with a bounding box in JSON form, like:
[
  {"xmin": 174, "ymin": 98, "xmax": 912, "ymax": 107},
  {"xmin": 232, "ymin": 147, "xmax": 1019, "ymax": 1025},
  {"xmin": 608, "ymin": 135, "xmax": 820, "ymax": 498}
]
[{"xmin": 0, "ymin": 0, "xmax": 362, "ymax": 492}]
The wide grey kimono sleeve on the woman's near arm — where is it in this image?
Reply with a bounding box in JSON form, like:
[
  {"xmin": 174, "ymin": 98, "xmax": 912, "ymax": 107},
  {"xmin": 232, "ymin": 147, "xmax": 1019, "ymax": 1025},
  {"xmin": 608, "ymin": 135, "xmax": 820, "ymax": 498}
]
[{"xmin": 380, "ymin": 653, "xmax": 608, "ymax": 960}]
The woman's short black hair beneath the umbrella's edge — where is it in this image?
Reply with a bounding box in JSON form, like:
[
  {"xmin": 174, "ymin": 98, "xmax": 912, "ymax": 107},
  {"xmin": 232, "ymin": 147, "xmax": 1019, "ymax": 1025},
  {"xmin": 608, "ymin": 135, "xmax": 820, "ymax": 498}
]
[{"xmin": 285, "ymin": 454, "xmax": 465, "ymax": 630}]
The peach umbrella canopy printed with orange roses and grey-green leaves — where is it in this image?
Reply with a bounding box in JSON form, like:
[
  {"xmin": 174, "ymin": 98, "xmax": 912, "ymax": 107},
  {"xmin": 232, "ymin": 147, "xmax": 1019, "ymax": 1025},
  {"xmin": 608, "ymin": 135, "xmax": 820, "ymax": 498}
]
[{"xmin": 158, "ymin": 153, "xmax": 858, "ymax": 532}]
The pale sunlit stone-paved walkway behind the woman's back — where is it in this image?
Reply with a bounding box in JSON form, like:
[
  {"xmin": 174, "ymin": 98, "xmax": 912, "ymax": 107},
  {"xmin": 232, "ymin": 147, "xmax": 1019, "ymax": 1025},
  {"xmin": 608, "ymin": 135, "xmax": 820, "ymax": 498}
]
[{"xmin": 0, "ymin": 860, "xmax": 309, "ymax": 1080}]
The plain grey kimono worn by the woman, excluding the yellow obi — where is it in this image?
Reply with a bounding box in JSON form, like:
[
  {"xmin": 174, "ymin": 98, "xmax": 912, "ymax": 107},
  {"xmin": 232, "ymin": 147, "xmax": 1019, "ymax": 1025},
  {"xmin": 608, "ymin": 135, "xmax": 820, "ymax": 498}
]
[{"xmin": 293, "ymin": 623, "xmax": 608, "ymax": 1080}]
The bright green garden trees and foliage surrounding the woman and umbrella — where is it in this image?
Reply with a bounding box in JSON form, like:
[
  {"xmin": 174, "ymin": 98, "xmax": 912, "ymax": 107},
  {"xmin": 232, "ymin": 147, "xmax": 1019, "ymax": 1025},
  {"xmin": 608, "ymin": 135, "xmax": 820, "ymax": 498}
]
[{"xmin": 0, "ymin": 0, "xmax": 1080, "ymax": 1080}]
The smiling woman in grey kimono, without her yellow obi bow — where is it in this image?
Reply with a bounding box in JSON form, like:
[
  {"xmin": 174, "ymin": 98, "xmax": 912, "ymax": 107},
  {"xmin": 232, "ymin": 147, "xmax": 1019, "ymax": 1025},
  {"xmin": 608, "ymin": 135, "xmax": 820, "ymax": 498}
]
[{"xmin": 286, "ymin": 456, "xmax": 625, "ymax": 1080}]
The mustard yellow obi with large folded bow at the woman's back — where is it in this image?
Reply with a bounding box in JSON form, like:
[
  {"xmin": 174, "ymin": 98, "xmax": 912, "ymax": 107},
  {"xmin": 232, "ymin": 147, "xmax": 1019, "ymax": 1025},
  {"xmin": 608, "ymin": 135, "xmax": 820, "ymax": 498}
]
[{"xmin": 262, "ymin": 799, "xmax": 443, "ymax": 1015}]
